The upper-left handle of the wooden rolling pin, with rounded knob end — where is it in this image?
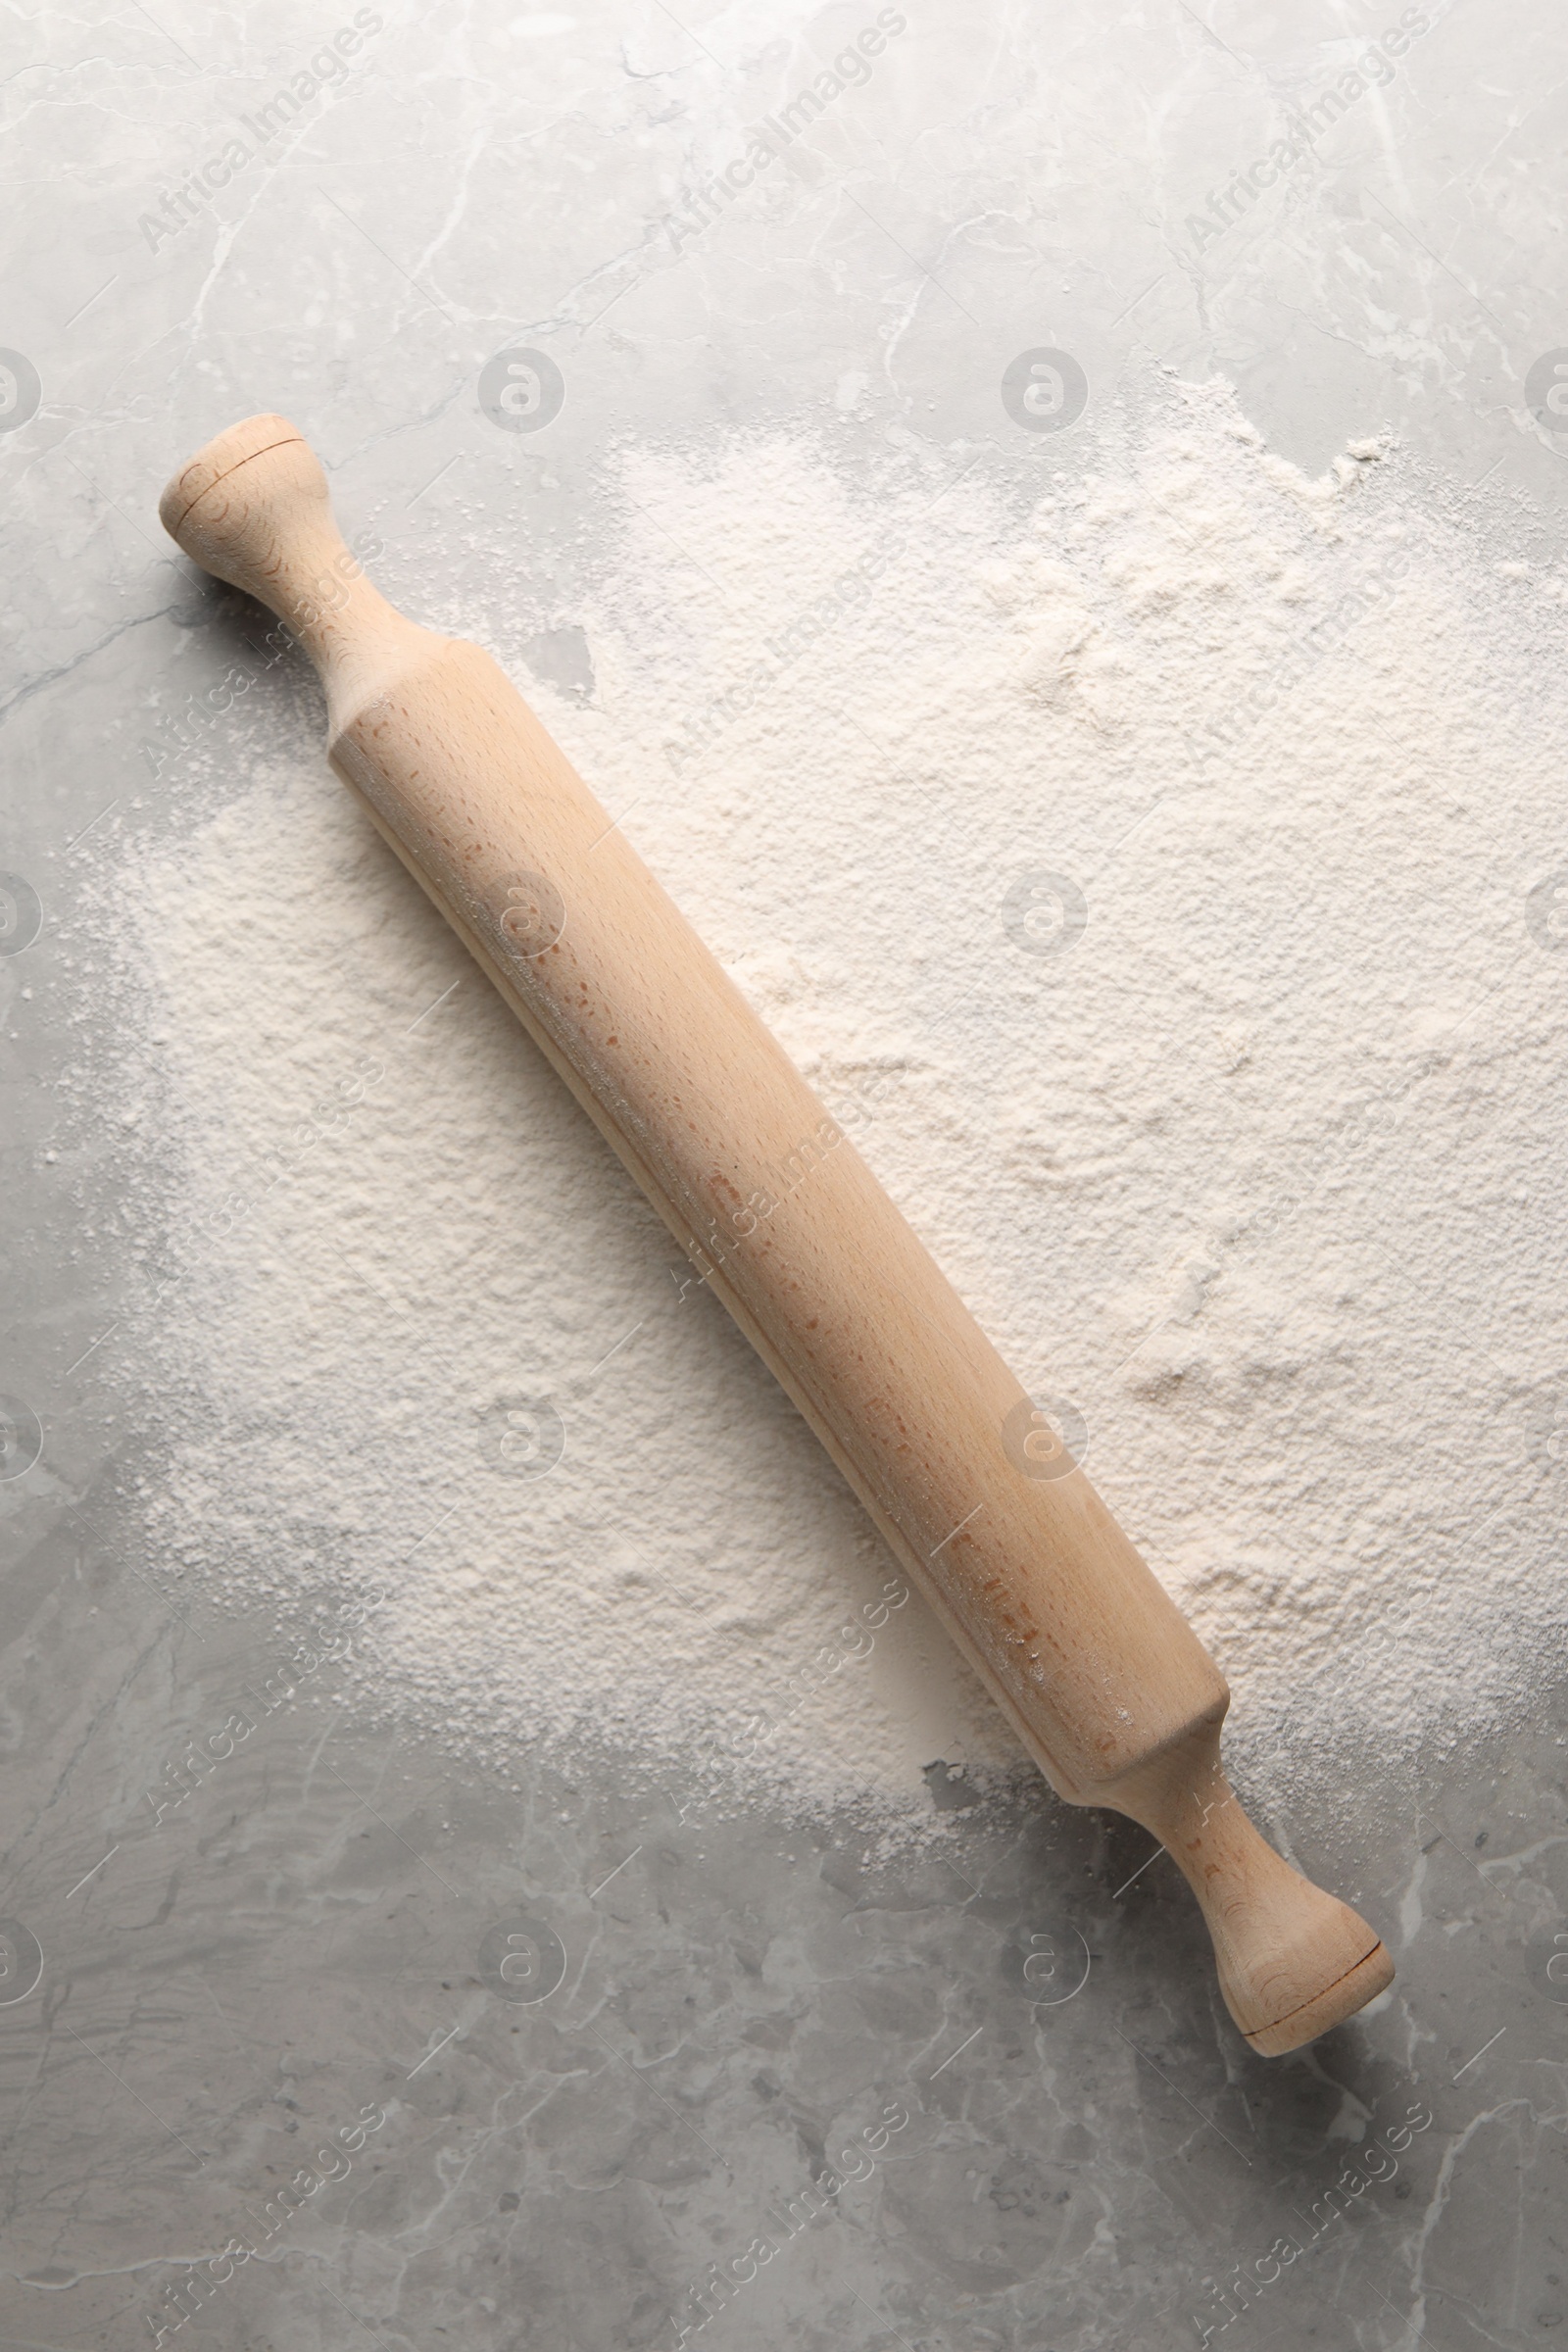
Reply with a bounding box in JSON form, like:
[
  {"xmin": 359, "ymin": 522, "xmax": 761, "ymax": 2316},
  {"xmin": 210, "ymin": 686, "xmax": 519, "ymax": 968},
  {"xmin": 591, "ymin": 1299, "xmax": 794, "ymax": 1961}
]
[{"xmin": 160, "ymin": 416, "xmax": 444, "ymax": 736}]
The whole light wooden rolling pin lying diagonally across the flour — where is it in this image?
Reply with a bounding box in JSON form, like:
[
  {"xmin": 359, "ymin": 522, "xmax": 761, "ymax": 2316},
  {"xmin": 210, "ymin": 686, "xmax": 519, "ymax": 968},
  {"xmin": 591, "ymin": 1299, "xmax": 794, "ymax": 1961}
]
[{"xmin": 160, "ymin": 416, "xmax": 1394, "ymax": 2056}]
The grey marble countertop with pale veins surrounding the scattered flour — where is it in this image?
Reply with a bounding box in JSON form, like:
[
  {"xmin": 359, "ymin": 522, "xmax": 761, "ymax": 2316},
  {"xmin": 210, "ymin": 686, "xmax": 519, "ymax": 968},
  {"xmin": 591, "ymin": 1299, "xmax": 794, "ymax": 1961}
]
[{"xmin": 0, "ymin": 0, "xmax": 1568, "ymax": 2352}]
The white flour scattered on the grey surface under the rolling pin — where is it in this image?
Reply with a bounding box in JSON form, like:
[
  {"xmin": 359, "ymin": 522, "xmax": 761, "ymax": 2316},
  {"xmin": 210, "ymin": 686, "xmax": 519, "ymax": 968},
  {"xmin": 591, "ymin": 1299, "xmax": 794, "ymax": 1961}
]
[{"xmin": 88, "ymin": 381, "xmax": 1568, "ymax": 1809}]
